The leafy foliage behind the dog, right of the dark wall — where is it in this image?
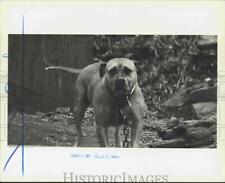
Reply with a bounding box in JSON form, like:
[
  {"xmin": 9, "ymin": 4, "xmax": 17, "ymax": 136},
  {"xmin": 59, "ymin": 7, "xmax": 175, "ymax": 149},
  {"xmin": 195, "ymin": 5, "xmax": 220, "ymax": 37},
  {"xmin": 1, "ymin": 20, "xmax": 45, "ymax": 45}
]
[{"xmin": 93, "ymin": 35, "xmax": 216, "ymax": 111}]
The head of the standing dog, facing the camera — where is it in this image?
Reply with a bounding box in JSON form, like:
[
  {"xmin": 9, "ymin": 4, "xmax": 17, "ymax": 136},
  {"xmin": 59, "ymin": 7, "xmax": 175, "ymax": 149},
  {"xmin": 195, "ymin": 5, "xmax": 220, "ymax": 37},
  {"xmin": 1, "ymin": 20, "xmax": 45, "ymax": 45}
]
[{"xmin": 99, "ymin": 58, "xmax": 137, "ymax": 98}]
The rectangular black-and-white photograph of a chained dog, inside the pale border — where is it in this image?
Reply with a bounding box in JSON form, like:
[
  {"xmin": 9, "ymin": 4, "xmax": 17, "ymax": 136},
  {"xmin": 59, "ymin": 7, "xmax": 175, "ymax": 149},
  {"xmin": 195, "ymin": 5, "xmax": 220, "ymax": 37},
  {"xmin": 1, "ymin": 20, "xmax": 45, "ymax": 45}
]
[{"xmin": 8, "ymin": 34, "xmax": 217, "ymax": 148}]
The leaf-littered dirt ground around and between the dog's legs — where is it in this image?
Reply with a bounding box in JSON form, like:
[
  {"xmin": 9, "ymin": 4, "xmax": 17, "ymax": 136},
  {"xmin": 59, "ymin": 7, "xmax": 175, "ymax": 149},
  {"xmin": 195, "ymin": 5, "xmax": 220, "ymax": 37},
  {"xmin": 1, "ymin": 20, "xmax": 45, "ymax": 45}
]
[{"xmin": 8, "ymin": 108, "xmax": 216, "ymax": 148}]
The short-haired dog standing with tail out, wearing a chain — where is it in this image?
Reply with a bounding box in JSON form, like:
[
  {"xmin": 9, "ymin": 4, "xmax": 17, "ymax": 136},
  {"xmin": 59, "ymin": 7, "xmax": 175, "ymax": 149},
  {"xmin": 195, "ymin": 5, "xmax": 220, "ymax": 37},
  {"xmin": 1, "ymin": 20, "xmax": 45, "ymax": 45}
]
[{"xmin": 46, "ymin": 58, "xmax": 147, "ymax": 147}]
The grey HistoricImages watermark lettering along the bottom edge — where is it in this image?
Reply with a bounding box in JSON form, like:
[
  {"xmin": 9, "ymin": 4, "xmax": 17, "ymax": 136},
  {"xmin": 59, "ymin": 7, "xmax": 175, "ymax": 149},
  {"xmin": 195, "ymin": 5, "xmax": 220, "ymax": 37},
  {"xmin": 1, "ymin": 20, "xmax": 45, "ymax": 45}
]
[{"xmin": 63, "ymin": 172, "xmax": 169, "ymax": 182}]
